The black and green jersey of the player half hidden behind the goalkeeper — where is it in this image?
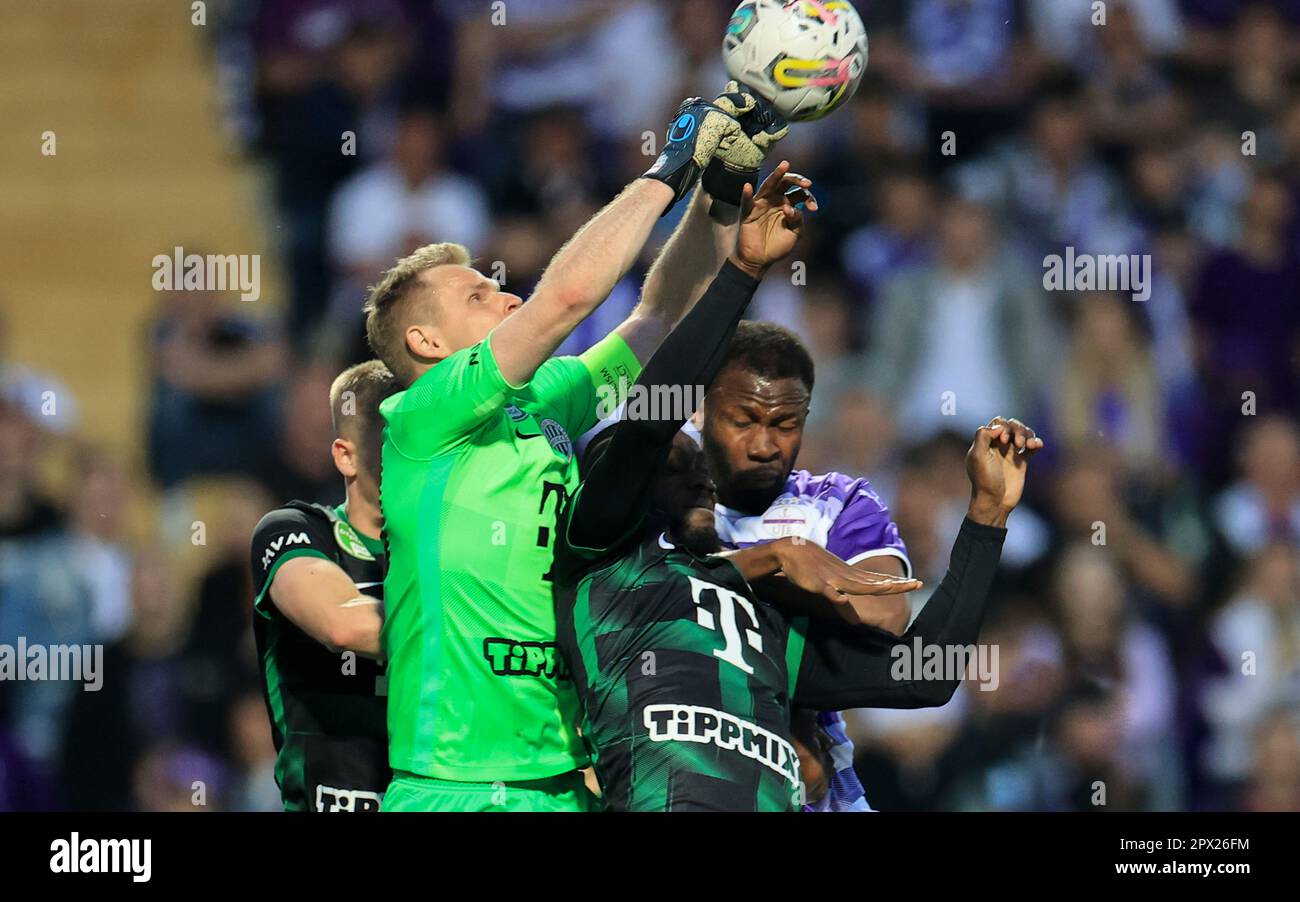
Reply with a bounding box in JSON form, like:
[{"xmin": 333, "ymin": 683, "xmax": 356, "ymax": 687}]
[{"xmin": 252, "ymin": 502, "xmax": 391, "ymax": 811}]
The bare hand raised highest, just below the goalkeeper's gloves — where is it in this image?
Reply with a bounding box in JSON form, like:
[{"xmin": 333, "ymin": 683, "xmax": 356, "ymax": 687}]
[{"xmin": 731, "ymin": 160, "xmax": 816, "ymax": 278}]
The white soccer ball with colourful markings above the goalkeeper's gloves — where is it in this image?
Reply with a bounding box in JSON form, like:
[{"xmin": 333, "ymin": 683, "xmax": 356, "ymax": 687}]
[{"xmin": 723, "ymin": 0, "xmax": 867, "ymax": 122}]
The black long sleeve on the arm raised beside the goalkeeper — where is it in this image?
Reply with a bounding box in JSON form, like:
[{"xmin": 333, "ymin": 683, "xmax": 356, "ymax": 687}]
[{"xmin": 567, "ymin": 261, "xmax": 758, "ymax": 550}]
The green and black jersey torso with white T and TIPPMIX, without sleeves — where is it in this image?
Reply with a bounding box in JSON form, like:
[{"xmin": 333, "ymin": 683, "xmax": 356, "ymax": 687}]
[{"xmin": 556, "ymin": 535, "xmax": 803, "ymax": 811}]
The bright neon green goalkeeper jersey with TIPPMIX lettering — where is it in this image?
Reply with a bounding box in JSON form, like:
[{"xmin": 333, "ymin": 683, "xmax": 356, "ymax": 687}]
[{"xmin": 380, "ymin": 335, "xmax": 640, "ymax": 782}]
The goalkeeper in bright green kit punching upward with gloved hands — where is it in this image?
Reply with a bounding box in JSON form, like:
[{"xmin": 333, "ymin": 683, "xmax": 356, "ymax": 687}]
[{"xmin": 365, "ymin": 84, "xmax": 785, "ymax": 811}]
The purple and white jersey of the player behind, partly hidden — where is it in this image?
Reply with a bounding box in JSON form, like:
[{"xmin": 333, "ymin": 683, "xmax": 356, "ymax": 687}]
[{"xmin": 714, "ymin": 469, "xmax": 911, "ymax": 811}]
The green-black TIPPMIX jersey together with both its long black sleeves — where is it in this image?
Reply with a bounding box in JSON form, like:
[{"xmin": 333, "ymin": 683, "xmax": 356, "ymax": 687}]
[{"xmin": 553, "ymin": 264, "xmax": 1005, "ymax": 811}]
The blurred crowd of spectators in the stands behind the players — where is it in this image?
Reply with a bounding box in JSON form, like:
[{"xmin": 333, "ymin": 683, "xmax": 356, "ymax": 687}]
[{"xmin": 0, "ymin": 0, "xmax": 1300, "ymax": 810}]
